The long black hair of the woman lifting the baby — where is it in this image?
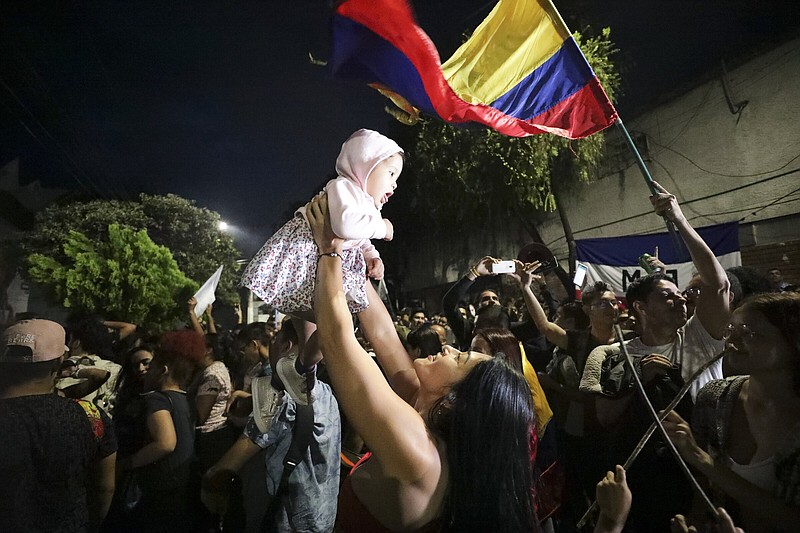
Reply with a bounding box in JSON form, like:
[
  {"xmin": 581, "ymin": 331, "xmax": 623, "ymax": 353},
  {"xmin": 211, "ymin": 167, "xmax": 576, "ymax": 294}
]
[{"xmin": 427, "ymin": 358, "xmax": 539, "ymax": 532}]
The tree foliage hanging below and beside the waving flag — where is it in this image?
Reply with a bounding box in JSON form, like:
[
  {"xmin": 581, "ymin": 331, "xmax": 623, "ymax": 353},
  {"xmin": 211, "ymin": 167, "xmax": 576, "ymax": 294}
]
[{"xmin": 410, "ymin": 28, "xmax": 620, "ymax": 235}]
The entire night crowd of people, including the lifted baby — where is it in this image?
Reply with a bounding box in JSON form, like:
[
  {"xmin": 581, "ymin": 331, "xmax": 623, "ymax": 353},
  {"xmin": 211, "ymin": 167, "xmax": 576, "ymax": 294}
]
[{"xmin": 0, "ymin": 130, "xmax": 800, "ymax": 533}]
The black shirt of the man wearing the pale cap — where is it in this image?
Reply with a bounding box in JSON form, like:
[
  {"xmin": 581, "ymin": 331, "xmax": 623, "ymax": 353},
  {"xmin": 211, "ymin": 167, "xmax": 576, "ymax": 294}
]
[{"xmin": 0, "ymin": 394, "xmax": 117, "ymax": 533}]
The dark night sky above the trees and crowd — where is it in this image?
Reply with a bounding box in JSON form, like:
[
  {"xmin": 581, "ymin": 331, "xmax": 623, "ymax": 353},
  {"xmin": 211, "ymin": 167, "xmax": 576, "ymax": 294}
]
[{"xmin": 0, "ymin": 0, "xmax": 800, "ymax": 253}]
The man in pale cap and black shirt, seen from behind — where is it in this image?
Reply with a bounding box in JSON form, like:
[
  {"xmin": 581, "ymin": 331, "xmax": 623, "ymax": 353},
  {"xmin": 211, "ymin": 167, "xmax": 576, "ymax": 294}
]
[{"xmin": 0, "ymin": 319, "xmax": 117, "ymax": 532}]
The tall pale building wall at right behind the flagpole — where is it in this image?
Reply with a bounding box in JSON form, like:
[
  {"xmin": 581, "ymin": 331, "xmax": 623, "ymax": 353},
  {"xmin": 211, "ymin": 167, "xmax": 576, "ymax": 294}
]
[{"xmin": 540, "ymin": 39, "xmax": 800, "ymax": 254}]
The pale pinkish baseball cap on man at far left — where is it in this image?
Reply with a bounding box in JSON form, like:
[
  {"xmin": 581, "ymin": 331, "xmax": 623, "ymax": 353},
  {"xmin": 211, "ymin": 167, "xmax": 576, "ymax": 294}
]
[{"xmin": 0, "ymin": 319, "xmax": 69, "ymax": 363}]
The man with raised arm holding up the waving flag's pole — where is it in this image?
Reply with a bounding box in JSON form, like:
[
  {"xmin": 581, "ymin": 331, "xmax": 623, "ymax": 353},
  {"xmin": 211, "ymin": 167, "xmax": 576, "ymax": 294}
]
[{"xmin": 580, "ymin": 184, "xmax": 731, "ymax": 531}]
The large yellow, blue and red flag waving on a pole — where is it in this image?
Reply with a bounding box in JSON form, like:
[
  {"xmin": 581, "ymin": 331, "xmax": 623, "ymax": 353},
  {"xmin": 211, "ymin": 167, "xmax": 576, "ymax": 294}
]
[{"xmin": 328, "ymin": 0, "xmax": 617, "ymax": 139}]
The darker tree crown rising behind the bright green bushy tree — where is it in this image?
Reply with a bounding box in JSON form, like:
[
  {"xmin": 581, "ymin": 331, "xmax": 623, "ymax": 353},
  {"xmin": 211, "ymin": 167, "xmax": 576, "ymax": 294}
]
[{"xmin": 26, "ymin": 194, "xmax": 241, "ymax": 302}]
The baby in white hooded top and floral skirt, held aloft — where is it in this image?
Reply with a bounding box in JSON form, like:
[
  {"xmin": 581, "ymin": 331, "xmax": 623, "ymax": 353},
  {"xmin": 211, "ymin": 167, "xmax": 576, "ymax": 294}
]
[{"xmin": 241, "ymin": 129, "xmax": 404, "ymax": 403}]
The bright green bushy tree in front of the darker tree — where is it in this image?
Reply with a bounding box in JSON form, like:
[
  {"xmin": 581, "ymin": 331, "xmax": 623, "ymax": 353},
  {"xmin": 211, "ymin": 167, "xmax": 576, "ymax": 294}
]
[{"xmin": 28, "ymin": 224, "xmax": 197, "ymax": 331}]
